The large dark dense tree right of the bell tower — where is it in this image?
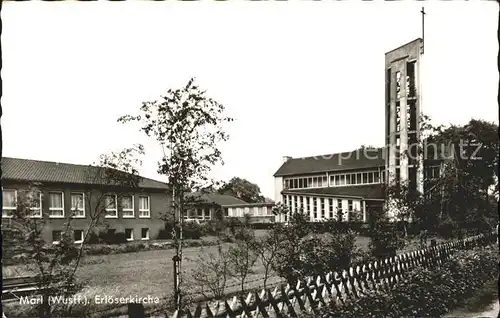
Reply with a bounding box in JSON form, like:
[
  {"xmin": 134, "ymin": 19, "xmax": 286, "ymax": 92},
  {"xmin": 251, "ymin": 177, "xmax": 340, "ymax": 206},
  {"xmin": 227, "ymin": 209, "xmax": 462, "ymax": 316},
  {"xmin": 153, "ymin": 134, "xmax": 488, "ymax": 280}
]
[{"xmin": 429, "ymin": 119, "xmax": 499, "ymax": 232}]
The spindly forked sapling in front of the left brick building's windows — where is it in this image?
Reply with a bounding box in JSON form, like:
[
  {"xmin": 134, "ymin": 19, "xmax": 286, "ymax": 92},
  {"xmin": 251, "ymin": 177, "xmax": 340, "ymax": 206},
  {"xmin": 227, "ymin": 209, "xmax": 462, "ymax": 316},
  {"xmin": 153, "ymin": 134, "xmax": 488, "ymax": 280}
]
[{"xmin": 7, "ymin": 147, "xmax": 141, "ymax": 317}]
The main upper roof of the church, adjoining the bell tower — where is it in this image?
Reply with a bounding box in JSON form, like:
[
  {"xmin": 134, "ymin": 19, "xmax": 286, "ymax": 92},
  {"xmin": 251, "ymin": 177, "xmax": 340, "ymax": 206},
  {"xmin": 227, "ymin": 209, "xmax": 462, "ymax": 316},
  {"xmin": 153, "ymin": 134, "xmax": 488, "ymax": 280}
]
[{"xmin": 274, "ymin": 148, "xmax": 385, "ymax": 177}]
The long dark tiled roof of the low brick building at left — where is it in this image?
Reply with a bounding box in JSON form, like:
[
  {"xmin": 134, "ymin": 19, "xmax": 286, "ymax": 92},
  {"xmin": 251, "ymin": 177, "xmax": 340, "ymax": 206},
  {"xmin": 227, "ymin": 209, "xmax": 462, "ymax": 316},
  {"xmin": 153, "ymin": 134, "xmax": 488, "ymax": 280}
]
[{"xmin": 2, "ymin": 157, "xmax": 168, "ymax": 189}]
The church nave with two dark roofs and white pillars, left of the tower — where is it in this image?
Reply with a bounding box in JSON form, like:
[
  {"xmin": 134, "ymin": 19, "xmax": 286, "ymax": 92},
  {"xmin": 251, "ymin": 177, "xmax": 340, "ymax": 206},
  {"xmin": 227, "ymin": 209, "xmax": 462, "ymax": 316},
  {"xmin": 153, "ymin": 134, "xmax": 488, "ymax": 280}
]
[{"xmin": 274, "ymin": 148, "xmax": 385, "ymax": 222}]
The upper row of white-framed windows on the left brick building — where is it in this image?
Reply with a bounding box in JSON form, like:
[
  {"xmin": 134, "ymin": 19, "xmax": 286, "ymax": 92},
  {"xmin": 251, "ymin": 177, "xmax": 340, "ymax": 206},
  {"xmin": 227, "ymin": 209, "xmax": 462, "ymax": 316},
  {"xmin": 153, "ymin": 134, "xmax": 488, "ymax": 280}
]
[{"xmin": 2, "ymin": 189, "xmax": 150, "ymax": 218}]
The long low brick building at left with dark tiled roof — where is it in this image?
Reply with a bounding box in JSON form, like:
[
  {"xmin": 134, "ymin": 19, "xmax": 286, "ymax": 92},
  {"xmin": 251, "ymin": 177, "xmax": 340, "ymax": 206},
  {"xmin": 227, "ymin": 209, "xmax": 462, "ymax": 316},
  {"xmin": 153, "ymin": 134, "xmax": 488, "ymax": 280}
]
[{"xmin": 2, "ymin": 157, "xmax": 171, "ymax": 243}]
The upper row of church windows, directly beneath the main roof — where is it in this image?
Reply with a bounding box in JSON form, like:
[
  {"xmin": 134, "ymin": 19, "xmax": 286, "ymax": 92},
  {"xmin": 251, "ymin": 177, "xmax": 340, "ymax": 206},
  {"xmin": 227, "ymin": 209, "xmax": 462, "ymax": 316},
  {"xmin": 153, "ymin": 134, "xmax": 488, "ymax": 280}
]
[{"xmin": 283, "ymin": 171, "xmax": 385, "ymax": 189}]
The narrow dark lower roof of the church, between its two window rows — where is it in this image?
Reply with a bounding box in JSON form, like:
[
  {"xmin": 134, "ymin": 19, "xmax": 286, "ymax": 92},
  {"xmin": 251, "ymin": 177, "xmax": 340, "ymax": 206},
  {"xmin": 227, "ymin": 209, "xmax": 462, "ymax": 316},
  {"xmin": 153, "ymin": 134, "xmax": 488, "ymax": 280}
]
[{"xmin": 281, "ymin": 184, "xmax": 385, "ymax": 200}]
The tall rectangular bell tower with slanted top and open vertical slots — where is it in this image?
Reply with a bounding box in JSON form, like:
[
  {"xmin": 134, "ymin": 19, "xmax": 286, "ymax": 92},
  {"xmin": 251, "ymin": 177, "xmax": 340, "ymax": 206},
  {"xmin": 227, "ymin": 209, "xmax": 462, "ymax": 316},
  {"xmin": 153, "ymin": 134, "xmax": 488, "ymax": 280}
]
[{"xmin": 385, "ymin": 38, "xmax": 423, "ymax": 191}]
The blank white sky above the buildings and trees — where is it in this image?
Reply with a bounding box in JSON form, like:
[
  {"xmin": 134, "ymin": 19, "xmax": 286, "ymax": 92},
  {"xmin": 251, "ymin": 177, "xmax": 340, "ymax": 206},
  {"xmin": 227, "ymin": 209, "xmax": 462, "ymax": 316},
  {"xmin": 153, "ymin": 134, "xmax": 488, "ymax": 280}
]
[{"xmin": 1, "ymin": 1, "xmax": 499, "ymax": 198}]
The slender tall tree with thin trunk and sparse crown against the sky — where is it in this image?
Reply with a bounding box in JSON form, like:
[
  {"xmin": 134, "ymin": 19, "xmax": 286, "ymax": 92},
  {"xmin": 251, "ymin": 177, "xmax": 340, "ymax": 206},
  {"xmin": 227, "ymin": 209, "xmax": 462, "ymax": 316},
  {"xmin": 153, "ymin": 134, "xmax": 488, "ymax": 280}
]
[{"xmin": 118, "ymin": 78, "xmax": 233, "ymax": 310}]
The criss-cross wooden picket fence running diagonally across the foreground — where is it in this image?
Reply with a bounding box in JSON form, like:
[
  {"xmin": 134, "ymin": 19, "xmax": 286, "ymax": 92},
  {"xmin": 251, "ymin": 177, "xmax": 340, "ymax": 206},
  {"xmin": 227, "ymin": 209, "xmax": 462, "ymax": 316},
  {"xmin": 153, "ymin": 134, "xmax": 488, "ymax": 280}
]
[{"xmin": 164, "ymin": 233, "xmax": 496, "ymax": 318}]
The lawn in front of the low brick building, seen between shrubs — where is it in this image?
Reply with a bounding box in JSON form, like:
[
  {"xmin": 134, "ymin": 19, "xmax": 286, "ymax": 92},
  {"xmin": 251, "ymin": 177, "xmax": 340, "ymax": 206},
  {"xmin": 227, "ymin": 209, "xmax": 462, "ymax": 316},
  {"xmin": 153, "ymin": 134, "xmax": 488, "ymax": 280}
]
[{"xmin": 2, "ymin": 230, "xmax": 442, "ymax": 311}]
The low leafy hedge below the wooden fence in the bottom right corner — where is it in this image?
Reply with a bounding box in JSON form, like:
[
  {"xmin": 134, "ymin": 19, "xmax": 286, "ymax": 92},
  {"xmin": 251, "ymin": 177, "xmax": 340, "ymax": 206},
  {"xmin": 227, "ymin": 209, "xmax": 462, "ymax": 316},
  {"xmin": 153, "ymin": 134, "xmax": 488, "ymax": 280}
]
[{"xmin": 314, "ymin": 246, "xmax": 498, "ymax": 318}]
